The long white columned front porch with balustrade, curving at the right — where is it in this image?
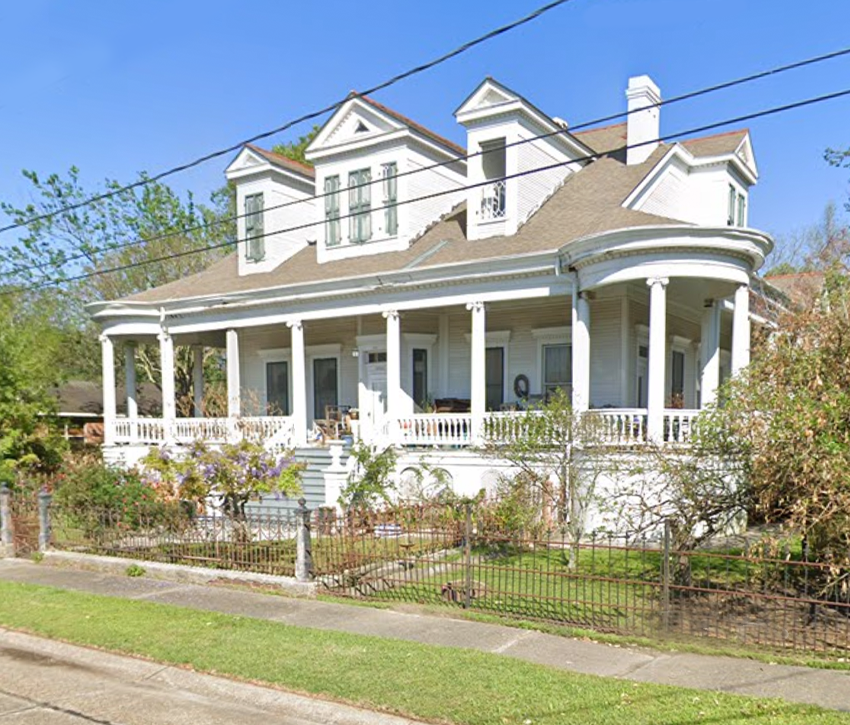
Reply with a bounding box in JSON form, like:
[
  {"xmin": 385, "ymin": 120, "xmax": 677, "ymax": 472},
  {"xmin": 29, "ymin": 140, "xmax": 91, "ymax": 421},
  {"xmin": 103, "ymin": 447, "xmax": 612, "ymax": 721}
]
[{"xmin": 102, "ymin": 279, "xmax": 749, "ymax": 450}]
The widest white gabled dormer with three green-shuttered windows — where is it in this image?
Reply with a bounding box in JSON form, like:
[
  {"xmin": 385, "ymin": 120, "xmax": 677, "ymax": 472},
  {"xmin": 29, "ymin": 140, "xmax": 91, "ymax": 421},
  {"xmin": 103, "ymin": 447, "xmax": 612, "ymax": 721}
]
[{"xmin": 306, "ymin": 93, "xmax": 466, "ymax": 263}]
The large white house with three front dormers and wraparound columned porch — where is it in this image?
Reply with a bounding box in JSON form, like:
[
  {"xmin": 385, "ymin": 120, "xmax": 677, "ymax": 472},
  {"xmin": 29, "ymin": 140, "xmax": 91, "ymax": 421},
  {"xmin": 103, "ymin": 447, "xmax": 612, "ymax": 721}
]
[{"xmin": 89, "ymin": 76, "xmax": 772, "ymax": 504}]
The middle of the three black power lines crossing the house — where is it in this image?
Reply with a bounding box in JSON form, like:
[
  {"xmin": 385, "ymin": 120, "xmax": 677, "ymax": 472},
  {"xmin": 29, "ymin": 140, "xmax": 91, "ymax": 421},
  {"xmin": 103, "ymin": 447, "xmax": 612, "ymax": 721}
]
[{"xmin": 6, "ymin": 41, "xmax": 850, "ymax": 275}]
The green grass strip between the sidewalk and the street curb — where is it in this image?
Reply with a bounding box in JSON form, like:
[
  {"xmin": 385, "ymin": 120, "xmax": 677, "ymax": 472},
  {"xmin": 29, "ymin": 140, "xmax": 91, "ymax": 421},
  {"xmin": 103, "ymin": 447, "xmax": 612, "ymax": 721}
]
[{"xmin": 0, "ymin": 582, "xmax": 850, "ymax": 725}]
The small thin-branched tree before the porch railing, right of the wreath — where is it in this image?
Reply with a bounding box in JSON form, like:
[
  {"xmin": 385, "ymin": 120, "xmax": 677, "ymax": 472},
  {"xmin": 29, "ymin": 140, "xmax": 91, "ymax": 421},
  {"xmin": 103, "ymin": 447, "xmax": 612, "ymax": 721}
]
[{"xmin": 481, "ymin": 389, "xmax": 610, "ymax": 568}]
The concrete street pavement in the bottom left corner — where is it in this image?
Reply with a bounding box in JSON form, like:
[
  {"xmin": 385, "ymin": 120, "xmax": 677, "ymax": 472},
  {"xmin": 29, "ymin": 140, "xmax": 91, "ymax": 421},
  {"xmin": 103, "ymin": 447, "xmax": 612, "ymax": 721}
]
[{"xmin": 0, "ymin": 630, "xmax": 422, "ymax": 725}]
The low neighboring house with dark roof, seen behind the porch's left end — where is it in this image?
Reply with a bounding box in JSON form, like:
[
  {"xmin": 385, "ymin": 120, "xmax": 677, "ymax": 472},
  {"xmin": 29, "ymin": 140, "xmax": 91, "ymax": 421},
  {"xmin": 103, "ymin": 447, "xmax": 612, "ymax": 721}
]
[{"xmin": 52, "ymin": 380, "xmax": 162, "ymax": 445}]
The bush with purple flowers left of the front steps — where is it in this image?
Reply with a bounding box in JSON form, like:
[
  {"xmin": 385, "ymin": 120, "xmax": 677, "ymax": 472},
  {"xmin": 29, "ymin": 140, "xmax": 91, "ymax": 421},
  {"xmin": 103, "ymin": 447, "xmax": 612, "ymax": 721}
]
[{"xmin": 142, "ymin": 441, "xmax": 304, "ymax": 519}]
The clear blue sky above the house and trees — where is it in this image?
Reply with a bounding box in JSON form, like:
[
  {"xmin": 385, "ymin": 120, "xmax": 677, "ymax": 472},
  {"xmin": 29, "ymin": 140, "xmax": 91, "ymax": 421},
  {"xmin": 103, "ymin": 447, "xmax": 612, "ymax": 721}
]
[{"xmin": 0, "ymin": 0, "xmax": 850, "ymax": 255}]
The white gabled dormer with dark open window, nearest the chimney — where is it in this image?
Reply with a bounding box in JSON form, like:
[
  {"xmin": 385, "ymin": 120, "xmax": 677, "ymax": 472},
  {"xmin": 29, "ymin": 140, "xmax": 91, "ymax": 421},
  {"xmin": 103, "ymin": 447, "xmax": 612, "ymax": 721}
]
[{"xmin": 455, "ymin": 78, "xmax": 593, "ymax": 239}]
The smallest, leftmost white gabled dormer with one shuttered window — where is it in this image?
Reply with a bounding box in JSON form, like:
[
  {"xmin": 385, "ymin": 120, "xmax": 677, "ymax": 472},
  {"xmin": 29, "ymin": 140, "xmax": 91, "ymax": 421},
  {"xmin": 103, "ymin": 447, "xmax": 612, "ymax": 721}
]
[{"xmin": 225, "ymin": 144, "xmax": 318, "ymax": 275}]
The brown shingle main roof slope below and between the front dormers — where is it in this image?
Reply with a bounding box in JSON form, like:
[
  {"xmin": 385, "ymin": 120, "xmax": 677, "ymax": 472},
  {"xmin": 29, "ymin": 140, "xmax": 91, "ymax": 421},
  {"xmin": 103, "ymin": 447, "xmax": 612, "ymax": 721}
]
[{"xmin": 127, "ymin": 145, "xmax": 682, "ymax": 302}]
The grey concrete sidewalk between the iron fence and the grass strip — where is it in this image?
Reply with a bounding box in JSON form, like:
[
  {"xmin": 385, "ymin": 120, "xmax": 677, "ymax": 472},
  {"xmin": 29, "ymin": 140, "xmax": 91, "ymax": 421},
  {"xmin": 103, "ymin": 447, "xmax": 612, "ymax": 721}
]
[{"xmin": 0, "ymin": 559, "xmax": 850, "ymax": 711}]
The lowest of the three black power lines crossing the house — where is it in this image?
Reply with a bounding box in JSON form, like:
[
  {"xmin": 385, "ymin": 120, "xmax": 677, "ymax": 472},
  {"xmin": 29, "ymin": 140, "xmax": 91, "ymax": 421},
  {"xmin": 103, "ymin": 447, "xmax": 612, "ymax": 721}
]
[{"xmin": 8, "ymin": 83, "xmax": 850, "ymax": 294}]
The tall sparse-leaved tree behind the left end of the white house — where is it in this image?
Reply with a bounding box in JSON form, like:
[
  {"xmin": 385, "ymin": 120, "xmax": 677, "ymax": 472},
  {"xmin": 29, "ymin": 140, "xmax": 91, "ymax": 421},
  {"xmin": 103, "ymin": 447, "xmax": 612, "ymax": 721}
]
[{"xmin": 0, "ymin": 167, "xmax": 235, "ymax": 396}]
